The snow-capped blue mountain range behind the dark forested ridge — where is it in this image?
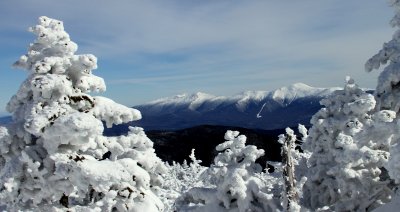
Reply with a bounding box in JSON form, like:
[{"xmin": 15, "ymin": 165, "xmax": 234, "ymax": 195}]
[{"xmin": 132, "ymin": 83, "xmax": 339, "ymax": 130}]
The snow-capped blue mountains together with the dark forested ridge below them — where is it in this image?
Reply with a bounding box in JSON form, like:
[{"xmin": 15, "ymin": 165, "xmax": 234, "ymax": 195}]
[{"xmin": 0, "ymin": 83, "xmax": 339, "ymax": 163}]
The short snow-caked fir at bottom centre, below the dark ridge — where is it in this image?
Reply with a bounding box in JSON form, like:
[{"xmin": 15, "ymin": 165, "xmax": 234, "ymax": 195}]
[{"xmin": 176, "ymin": 131, "xmax": 282, "ymax": 212}]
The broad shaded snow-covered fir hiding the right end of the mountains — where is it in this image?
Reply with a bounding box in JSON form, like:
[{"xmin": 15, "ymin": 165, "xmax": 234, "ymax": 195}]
[{"xmin": 303, "ymin": 78, "xmax": 396, "ymax": 211}]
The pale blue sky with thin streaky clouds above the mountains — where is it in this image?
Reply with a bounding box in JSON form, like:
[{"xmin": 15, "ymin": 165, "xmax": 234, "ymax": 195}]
[{"xmin": 0, "ymin": 0, "xmax": 394, "ymax": 114}]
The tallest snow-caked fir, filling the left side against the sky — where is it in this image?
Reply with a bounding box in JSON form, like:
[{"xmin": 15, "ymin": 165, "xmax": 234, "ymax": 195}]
[{"xmin": 0, "ymin": 16, "xmax": 165, "ymax": 211}]
